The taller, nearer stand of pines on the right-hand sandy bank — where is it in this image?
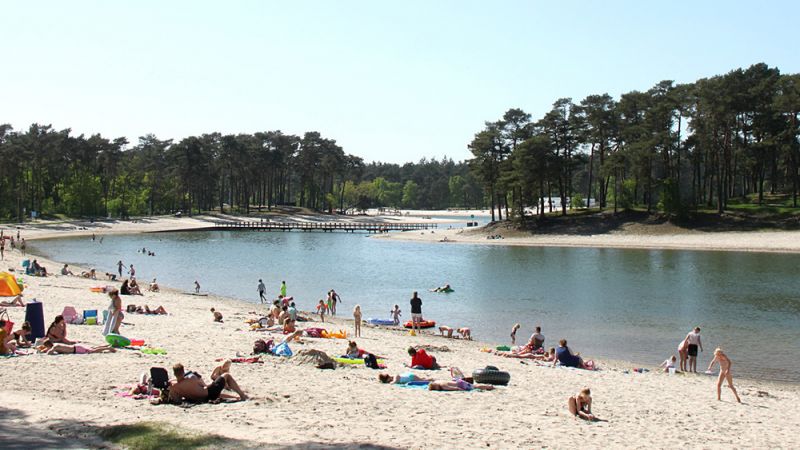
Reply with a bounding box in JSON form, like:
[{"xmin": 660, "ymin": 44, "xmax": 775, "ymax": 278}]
[{"xmin": 469, "ymin": 63, "xmax": 800, "ymax": 220}]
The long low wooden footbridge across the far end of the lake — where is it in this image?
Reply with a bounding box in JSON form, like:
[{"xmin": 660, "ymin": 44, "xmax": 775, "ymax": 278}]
[{"xmin": 213, "ymin": 220, "xmax": 436, "ymax": 233}]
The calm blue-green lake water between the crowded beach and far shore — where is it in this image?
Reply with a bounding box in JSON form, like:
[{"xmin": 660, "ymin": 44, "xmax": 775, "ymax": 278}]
[{"xmin": 35, "ymin": 232, "xmax": 800, "ymax": 382}]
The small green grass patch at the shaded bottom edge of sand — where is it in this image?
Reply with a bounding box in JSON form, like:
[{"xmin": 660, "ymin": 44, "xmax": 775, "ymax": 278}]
[{"xmin": 100, "ymin": 422, "xmax": 230, "ymax": 450}]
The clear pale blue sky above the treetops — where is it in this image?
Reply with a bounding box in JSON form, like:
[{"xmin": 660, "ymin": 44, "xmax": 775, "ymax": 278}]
[{"xmin": 0, "ymin": 0, "xmax": 800, "ymax": 163}]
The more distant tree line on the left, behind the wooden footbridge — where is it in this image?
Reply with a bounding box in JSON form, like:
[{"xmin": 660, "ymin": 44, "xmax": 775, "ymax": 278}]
[{"xmin": 0, "ymin": 124, "xmax": 483, "ymax": 221}]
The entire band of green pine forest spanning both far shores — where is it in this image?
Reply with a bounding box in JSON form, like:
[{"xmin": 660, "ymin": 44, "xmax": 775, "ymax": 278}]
[{"xmin": 0, "ymin": 63, "xmax": 800, "ymax": 221}]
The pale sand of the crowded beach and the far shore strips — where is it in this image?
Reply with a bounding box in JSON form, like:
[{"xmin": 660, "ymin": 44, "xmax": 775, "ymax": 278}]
[{"xmin": 0, "ymin": 218, "xmax": 800, "ymax": 448}]
